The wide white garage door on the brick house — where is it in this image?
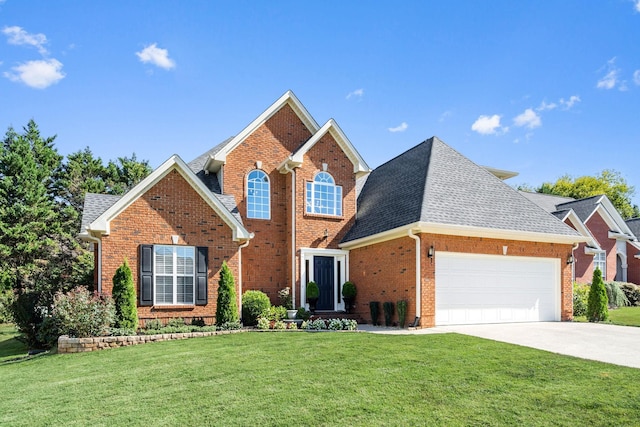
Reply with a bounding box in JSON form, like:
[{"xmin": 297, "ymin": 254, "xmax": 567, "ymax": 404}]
[{"xmin": 435, "ymin": 252, "xmax": 560, "ymax": 325}]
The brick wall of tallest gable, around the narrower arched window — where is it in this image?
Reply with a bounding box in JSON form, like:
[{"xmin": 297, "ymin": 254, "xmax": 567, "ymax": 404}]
[{"xmin": 223, "ymin": 104, "xmax": 311, "ymax": 304}]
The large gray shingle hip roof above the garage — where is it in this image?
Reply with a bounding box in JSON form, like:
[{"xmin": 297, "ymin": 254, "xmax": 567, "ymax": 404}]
[{"xmin": 343, "ymin": 137, "xmax": 578, "ymax": 242}]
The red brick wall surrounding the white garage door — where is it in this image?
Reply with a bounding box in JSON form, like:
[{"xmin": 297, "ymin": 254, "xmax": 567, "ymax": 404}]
[{"xmin": 349, "ymin": 234, "xmax": 573, "ymax": 327}]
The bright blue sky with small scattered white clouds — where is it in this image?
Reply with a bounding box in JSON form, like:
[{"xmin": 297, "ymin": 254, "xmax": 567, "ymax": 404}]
[{"xmin": 0, "ymin": 0, "xmax": 640, "ymax": 204}]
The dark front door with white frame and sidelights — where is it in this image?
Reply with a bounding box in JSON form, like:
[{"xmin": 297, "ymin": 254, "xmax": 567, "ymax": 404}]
[{"xmin": 298, "ymin": 248, "xmax": 348, "ymax": 311}]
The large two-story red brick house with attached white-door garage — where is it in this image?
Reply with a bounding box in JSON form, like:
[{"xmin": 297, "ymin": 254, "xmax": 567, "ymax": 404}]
[{"xmin": 81, "ymin": 92, "xmax": 587, "ymax": 326}]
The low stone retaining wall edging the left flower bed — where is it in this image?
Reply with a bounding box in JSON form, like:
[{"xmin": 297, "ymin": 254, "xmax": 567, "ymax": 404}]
[{"xmin": 58, "ymin": 329, "xmax": 244, "ymax": 353}]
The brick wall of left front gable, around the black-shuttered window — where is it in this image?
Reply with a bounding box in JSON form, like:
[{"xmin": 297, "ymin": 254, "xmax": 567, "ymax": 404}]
[{"xmin": 102, "ymin": 169, "xmax": 238, "ymax": 324}]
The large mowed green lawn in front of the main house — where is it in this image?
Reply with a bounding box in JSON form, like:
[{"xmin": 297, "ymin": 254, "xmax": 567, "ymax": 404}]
[{"xmin": 0, "ymin": 332, "xmax": 640, "ymax": 426}]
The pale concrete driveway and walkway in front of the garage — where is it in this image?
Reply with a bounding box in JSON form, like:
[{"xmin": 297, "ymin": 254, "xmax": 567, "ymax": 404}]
[{"xmin": 358, "ymin": 322, "xmax": 640, "ymax": 368}]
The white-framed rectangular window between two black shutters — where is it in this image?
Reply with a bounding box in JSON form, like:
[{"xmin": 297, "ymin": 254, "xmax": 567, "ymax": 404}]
[{"xmin": 153, "ymin": 245, "xmax": 195, "ymax": 305}]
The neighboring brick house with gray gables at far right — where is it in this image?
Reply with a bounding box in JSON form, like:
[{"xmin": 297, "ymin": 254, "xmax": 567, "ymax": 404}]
[{"xmin": 522, "ymin": 192, "xmax": 640, "ymax": 283}]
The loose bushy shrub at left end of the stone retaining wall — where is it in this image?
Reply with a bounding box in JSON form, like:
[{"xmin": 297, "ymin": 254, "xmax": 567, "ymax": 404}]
[{"xmin": 52, "ymin": 286, "xmax": 116, "ymax": 338}]
